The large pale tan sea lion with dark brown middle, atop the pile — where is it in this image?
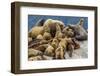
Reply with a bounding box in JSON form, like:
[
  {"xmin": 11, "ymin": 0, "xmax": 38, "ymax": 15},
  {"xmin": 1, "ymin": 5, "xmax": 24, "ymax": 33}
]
[{"xmin": 43, "ymin": 19, "xmax": 65, "ymax": 38}]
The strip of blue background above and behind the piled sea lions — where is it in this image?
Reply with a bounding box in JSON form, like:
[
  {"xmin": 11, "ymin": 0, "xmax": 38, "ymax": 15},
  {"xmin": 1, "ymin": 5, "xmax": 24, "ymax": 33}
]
[{"xmin": 28, "ymin": 15, "xmax": 88, "ymax": 30}]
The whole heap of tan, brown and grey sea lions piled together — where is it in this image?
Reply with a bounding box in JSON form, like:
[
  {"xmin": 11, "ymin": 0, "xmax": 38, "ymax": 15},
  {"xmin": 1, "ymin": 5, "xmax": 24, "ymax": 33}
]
[{"xmin": 28, "ymin": 19, "xmax": 87, "ymax": 61}]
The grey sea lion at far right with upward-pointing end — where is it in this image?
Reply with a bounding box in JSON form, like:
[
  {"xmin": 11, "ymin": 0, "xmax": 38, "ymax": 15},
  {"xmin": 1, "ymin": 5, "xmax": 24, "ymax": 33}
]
[{"xmin": 68, "ymin": 19, "xmax": 88, "ymax": 41}]
